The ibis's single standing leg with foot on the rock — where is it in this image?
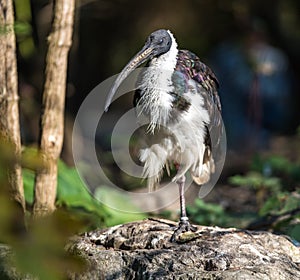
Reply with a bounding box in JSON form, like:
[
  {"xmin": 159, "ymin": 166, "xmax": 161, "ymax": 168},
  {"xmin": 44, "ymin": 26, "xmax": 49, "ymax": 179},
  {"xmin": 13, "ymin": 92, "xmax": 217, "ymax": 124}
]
[{"xmin": 171, "ymin": 175, "xmax": 197, "ymax": 242}]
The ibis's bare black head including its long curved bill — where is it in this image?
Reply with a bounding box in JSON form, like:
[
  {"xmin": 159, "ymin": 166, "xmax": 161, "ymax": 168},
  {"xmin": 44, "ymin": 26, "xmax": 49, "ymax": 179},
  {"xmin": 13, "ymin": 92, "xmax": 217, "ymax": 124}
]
[{"xmin": 105, "ymin": 29, "xmax": 173, "ymax": 111}]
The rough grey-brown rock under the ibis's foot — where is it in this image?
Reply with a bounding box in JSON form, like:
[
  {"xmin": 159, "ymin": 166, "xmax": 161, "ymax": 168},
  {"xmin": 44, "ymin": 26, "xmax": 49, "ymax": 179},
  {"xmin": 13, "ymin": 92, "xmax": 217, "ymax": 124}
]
[{"xmin": 67, "ymin": 219, "xmax": 300, "ymax": 280}]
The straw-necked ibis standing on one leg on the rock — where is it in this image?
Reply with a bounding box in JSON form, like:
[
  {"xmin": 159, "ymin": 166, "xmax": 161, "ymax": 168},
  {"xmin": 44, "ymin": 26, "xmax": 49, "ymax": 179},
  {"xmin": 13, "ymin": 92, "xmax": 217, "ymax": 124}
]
[{"xmin": 104, "ymin": 29, "xmax": 223, "ymax": 241}]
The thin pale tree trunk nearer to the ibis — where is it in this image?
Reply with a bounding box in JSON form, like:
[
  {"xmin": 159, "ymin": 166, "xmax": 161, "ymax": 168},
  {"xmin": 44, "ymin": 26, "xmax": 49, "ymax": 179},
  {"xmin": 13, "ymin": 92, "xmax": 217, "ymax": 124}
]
[{"xmin": 33, "ymin": 0, "xmax": 75, "ymax": 217}]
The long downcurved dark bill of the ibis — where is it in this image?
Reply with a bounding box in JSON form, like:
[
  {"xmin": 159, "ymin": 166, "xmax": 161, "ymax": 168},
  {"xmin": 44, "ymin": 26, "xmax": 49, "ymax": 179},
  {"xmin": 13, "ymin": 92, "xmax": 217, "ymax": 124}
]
[{"xmin": 104, "ymin": 44, "xmax": 153, "ymax": 112}]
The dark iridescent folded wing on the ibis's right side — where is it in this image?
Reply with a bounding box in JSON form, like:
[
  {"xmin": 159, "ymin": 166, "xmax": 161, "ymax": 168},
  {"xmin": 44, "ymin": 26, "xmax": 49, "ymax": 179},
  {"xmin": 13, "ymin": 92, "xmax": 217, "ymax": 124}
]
[{"xmin": 175, "ymin": 50, "xmax": 223, "ymax": 158}]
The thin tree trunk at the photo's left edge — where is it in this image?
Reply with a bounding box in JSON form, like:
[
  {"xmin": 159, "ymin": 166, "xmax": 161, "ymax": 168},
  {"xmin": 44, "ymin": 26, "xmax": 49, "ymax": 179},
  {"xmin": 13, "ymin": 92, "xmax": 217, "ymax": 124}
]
[{"xmin": 0, "ymin": 0, "xmax": 25, "ymax": 211}]
